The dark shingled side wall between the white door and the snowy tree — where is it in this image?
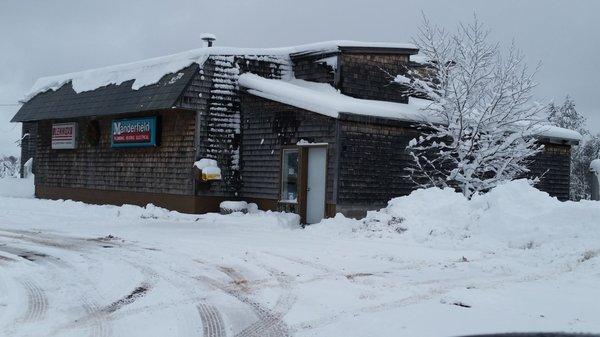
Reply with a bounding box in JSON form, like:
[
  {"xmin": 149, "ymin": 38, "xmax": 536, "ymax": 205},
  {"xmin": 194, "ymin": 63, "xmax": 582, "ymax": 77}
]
[{"xmin": 336, "ymin": 115, "xmax": 418, "ymax": 217}]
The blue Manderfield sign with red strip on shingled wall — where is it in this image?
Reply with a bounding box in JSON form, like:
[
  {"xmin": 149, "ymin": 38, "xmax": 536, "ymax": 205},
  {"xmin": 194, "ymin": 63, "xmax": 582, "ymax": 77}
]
[{"xmin": 110, "ymin": 116, "xmax": 156, "ymax": 147}]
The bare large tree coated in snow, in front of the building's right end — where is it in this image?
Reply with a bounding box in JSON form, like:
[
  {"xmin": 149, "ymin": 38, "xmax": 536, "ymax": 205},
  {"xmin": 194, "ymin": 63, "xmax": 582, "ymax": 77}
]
[{"xmin": 395, "ymin": 17, "xmax": 544, "ymax": 197}]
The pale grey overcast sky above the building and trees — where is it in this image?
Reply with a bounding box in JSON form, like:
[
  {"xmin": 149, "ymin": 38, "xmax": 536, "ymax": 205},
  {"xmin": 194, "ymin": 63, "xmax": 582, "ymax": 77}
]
[{"xmin": 0, "ymin": 0, "xmax": 600, "ymax": 154}]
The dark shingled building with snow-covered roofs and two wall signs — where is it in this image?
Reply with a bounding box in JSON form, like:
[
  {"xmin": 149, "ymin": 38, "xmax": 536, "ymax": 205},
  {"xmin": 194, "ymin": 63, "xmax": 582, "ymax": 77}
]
[{"xmin": 13, "ymin": 41, "xmax": 579, "ymax": 223}]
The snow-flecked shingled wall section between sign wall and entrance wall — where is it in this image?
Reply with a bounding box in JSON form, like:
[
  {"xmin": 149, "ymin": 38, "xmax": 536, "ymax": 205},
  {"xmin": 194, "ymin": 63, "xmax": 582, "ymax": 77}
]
[{"xmin": 178, "ymin": 55, "xmax": 289, "ymax": 198}]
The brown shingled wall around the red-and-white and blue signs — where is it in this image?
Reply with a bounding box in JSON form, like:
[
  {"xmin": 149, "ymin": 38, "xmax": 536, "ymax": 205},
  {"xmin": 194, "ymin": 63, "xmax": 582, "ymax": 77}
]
[{"xmin": 35, "ymin": 110, "xmax": 195, "ymax": 195}]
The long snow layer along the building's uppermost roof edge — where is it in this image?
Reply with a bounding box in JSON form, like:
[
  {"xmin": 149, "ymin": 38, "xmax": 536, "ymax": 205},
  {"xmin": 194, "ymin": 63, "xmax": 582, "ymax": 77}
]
[{"xmin": 23, "ymin": 40, "xmax": 417, "ymax": 101}]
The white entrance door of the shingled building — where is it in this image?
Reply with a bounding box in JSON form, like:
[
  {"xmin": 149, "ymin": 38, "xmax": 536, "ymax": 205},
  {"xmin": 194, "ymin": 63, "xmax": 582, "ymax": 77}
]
[{"xmin": 306, "ymin": 147, "xmax": 327, "ymax": 224}]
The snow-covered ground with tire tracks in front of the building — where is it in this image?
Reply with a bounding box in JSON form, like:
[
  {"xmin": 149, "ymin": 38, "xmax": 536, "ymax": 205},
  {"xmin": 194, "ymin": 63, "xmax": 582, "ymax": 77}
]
[{"xmin": 0, "ymin": 179, "xmax": 600, "ymax": 337}]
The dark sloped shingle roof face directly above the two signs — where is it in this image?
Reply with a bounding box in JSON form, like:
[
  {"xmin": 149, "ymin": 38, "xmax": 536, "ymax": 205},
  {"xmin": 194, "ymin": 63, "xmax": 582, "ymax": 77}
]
[{"xmin": 11, "ymin": 64, "xmax": 199, "ymax": 122}]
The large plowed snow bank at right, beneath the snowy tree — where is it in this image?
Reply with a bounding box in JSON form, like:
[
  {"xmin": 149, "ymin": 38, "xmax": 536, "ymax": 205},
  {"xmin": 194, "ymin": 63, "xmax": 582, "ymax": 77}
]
[{"xmin": 311, "ymin": 180, "xmax": 600, "ymax": 258}]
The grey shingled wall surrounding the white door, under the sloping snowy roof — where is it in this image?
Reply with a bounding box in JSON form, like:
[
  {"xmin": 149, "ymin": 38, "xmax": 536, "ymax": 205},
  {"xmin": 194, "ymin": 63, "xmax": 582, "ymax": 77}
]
[{"xmin": 240, "ymin": 94, "xmax": 337, "ymax": 204}]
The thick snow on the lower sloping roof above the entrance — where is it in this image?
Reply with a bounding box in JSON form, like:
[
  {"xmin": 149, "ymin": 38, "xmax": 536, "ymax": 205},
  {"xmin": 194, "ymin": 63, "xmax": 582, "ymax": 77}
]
[{"xmin": 239, "ymin": 73, "xmax": 429, "ymax": 122}]
